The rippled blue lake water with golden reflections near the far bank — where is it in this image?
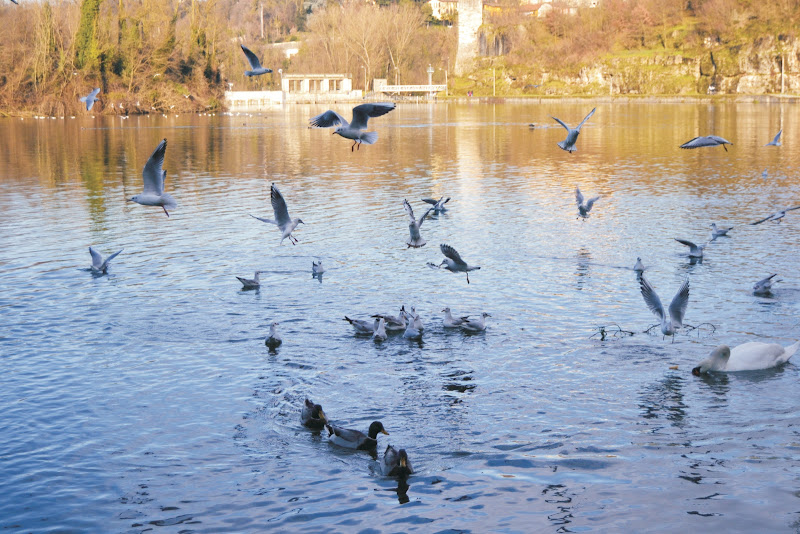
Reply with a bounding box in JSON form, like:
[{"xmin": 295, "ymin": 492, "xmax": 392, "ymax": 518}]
[{"xmin": 0, "ymin": 101, "xmax": 800, "ymax": 532}]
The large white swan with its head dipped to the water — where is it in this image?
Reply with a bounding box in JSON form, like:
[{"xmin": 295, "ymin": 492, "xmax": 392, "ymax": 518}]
[{"xmin": 692, "ymin": 341, "xmax": 800, "ymax": 376}]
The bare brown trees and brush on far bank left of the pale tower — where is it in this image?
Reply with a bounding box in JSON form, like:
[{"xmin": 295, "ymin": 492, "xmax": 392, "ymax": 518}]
[{"xmin": 0, "ymin": 0, "xmax": 455, "ymax": 115}]
